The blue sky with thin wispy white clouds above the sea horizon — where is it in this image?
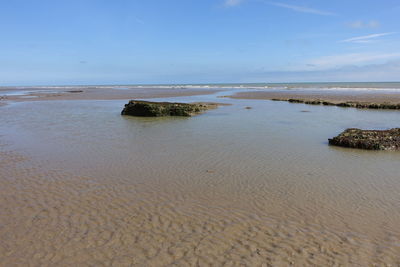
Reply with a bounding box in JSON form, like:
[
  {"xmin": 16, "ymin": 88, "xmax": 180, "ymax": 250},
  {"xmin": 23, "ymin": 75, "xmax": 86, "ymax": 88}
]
[{"xmin": 0, "ymin": 0, "xmax": 400, "ymax": 86}]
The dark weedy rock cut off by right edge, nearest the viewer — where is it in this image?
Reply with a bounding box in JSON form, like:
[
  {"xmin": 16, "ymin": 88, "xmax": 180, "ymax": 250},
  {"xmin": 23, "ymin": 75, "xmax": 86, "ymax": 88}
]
[{"xmin": 329, "ymin": 128, "xmax": 400, "ymax": 150}]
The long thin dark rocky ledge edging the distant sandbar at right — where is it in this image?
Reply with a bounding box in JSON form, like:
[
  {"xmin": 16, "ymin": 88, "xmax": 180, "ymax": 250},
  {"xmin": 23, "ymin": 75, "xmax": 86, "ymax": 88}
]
[{"xmin": 271, "ymin": 98, "xmax": 400, "ymax": 109}]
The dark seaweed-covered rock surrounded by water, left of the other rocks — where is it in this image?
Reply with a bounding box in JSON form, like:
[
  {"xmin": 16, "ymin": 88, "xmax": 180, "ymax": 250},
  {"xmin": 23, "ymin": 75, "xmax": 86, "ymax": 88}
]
[{"xmin": 121, "ymin": 100, "xmax": 216, "ymax": 117}]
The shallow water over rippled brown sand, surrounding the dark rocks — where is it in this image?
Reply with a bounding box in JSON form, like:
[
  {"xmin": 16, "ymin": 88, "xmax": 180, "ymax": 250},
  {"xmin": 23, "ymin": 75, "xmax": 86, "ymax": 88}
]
[{"xmin": 0, "ymin": 90, "xmax": 400, "ymax": 266}]
